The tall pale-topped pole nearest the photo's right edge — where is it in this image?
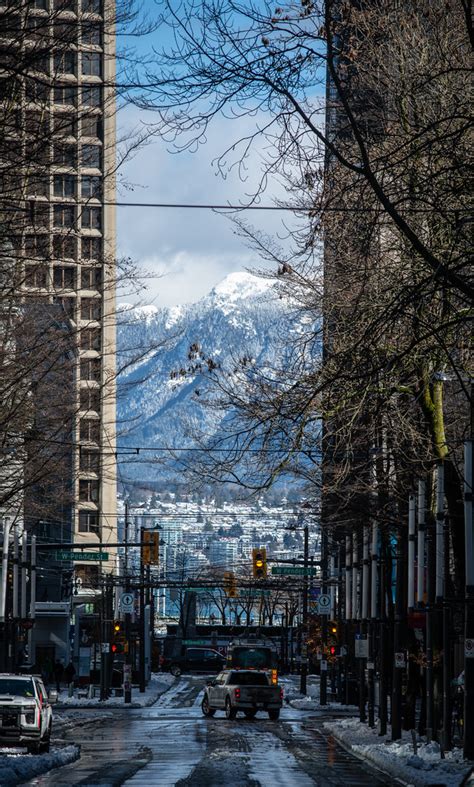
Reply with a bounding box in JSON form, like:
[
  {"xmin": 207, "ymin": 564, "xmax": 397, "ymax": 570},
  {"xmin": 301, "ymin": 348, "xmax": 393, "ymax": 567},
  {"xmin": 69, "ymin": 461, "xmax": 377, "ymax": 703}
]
[{"xmin": 464, "ymin": 440, "xmax": 474, "ymax": 760}]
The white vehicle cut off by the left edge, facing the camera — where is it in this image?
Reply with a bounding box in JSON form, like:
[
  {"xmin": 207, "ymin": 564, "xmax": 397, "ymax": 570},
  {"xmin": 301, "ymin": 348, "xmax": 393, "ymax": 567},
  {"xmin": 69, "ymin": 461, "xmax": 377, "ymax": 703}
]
[{"xmin": 0, "ymin": 673, "xmax": 57, "ymax": 754}]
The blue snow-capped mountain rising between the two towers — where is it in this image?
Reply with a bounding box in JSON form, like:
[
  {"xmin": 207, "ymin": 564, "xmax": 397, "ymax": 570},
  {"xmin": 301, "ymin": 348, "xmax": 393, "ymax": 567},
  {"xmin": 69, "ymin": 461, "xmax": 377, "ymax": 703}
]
[{"xmin": 118, "ymin": 273, "xmax": 314, "ymax": 490}]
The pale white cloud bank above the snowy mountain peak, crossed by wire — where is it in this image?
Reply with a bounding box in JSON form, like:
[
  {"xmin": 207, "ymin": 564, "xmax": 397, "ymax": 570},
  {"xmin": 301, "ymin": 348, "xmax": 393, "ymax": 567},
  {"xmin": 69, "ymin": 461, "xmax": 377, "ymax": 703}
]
[{"xmin": 117, "ymin": 102, "xmax": 290, "ymax": 306}]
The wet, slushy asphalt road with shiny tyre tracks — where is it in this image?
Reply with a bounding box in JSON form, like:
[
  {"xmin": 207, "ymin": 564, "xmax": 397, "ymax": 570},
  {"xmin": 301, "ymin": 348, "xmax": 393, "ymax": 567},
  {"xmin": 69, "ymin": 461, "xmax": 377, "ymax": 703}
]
[{"xmin": 28, "ymin": 676, "xmax": 393, "ymax": 787}]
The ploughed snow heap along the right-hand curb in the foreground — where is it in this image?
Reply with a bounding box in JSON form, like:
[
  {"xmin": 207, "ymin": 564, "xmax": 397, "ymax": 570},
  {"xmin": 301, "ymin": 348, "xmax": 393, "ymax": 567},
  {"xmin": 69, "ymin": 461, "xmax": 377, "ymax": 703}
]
[{"xmin": 324, "ymin": 719, "xmax": 472, "ymax": 787}]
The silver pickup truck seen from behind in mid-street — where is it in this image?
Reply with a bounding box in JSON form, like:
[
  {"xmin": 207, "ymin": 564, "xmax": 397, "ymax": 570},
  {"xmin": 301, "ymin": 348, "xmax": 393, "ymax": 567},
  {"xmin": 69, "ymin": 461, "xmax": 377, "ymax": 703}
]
[{"xmin": 201, "ymin": 670, "xmax": 283, "ymax": 721}]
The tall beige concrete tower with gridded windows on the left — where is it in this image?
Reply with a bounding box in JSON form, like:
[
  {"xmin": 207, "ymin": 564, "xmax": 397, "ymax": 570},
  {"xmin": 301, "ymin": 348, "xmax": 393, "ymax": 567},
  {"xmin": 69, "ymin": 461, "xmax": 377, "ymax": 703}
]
[{"xmin": 0, "ymin": 0, "xmax": 117, "ymax": 656}]
